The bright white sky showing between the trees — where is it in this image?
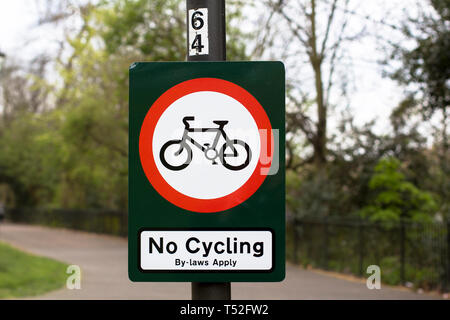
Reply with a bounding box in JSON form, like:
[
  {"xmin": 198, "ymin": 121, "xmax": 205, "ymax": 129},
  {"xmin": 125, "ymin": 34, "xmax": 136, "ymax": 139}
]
[{"xmin": 0, "ymin": 0, "xmax": 428, "ymax": 139}]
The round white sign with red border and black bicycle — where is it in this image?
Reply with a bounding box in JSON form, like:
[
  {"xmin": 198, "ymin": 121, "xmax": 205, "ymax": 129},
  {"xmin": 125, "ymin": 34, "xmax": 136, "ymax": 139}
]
[{"xmin": 139, "ymin": 78, "xmax": 272, "ymax": 212}]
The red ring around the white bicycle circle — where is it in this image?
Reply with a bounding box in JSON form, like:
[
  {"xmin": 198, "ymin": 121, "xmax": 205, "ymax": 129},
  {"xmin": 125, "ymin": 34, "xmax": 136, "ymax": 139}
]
[{"xmin": 139, "ymin": 78, "xmax": 273, "ymax": 212}]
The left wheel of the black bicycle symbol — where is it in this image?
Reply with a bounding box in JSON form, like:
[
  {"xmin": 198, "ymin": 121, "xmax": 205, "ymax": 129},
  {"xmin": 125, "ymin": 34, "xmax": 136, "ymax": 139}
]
[{"xmin": 159, "ymin": 140, "xmax": 192, "ymax": 171}]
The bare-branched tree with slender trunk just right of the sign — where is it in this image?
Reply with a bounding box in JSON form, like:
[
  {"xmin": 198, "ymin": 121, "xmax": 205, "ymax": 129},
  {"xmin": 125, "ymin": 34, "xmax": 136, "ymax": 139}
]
[{"xmin": 264, "ymin": 0, "xmax": 363, "ymax": 169}]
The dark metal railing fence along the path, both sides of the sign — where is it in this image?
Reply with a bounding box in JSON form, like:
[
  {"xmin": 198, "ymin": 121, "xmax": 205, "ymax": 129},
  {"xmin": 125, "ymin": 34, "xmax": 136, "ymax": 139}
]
[{"xmin": 6, "ymin": 209, "xmax": 450, "ymax": 291}]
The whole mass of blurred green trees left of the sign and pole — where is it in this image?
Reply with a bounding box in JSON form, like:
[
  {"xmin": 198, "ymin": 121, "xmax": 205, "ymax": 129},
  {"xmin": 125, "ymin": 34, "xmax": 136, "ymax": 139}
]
[{"xmin": 0, "ymin": 0, "xmax": 250, "ymax": 210}]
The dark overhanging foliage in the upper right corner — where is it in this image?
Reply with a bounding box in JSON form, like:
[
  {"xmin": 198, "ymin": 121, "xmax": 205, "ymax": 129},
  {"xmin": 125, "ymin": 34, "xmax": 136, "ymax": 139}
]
[{"xmin": 391, "ymin": 0, "xmax": 450, "ymax": 116}]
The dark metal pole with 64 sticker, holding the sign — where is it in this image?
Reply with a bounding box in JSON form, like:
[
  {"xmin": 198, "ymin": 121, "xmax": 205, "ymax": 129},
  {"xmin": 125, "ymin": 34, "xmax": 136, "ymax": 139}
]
[{"xmin": 186, "ymin": 0, "xmax": 231, "ymax": 300}]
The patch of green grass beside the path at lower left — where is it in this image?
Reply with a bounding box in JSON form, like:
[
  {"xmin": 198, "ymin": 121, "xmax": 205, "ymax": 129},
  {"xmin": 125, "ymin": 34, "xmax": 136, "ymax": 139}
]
[{"xmin": 0, "ymin": 243, "xmax": 67, "ymax": 299}]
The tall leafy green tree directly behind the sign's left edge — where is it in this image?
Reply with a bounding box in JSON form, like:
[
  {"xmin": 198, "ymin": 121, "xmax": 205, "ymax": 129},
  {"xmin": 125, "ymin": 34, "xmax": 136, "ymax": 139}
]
[{"xmin": 51, "ymin": 0, "xmax": 250, "ymax": 209}]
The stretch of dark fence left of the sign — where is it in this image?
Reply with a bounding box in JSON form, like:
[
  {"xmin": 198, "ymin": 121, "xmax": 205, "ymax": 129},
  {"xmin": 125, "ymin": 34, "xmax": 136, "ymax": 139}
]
[{"xmin": 6, "ymin": 208, "xmax": 128, "ymax": 237}]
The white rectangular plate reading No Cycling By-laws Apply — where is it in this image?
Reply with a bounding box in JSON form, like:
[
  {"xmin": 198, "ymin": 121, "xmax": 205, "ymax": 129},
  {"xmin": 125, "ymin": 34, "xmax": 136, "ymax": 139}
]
[{"xmin": 139, "ymin": 230, "xmax": 273, "ymax": 272}]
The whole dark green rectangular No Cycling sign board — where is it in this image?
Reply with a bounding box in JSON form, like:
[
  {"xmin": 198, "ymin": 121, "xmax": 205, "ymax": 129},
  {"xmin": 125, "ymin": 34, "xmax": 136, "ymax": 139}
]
[{"xmin": 128, "ymin": 62, "xmax": 285, "ymax": 282}]
